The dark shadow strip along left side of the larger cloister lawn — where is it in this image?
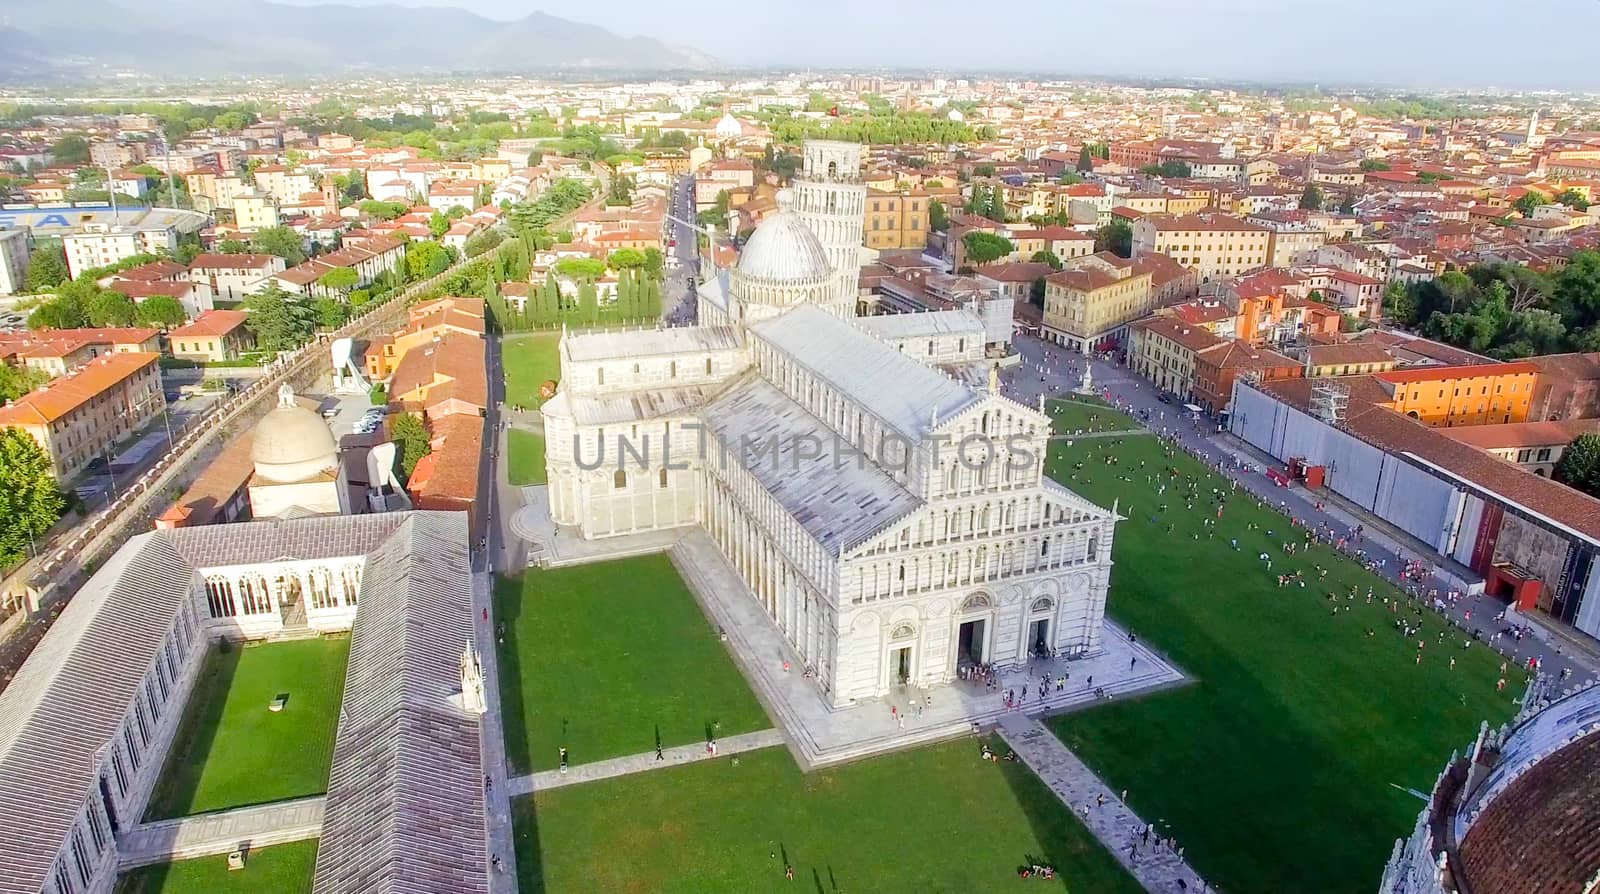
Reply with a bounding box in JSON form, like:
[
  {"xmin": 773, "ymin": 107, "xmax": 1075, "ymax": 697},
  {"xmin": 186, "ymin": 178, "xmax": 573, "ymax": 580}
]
[{"xmin": 144, "ymin": 640, "xmax": 248, "ymax": 825}]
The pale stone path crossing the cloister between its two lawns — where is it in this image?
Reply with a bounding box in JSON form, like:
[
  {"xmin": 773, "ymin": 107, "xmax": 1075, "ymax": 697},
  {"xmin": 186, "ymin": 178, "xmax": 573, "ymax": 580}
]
[{"xmin": 117, "ymin": 795, "xmax": 325, "ymax": 868}]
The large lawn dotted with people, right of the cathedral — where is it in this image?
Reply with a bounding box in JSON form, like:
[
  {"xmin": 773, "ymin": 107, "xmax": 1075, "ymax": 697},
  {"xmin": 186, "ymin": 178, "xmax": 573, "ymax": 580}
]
[{"xmin": 1050, "ymin": 437, "xmax": 1523, "ymax": 894}]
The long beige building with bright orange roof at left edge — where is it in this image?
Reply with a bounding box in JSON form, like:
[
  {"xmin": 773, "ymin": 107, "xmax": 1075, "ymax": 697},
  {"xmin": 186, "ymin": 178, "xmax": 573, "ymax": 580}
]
[{"xmin": 0, "ymin": 352, "xmax": 166, "ymax": 480}]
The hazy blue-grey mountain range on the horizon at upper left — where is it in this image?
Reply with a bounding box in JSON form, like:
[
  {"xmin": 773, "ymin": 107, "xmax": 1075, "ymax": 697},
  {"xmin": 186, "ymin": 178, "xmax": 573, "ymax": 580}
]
[{"xmin": 0, "ymin": 0, "xmax": 715, "ymax": 80}]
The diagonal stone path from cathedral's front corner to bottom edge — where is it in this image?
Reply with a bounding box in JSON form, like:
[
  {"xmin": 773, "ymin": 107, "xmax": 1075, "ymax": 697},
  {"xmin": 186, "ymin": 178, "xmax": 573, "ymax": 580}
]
[{"xmin": 1000, "ymin": 713, "xmax": 1210, "ymax": 894}]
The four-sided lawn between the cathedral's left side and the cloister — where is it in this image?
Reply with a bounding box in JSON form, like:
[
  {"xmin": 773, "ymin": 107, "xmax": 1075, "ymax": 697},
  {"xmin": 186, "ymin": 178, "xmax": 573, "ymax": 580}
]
[{"xmin": 494, "ymin": 555, "xmax": 771, "ymax": 772}]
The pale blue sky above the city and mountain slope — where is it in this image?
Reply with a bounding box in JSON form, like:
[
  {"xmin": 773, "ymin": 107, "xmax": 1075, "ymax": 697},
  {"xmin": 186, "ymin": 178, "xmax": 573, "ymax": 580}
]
[{"xmin": 272, "ymin": 0, "xmax": 1600, "ymax": 91}]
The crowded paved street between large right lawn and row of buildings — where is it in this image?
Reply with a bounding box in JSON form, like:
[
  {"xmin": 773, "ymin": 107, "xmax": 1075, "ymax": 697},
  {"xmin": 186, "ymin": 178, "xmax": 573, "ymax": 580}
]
[{"xmin": 1002, "ymin": 336, "xmax": 1600, "ymax": 681}]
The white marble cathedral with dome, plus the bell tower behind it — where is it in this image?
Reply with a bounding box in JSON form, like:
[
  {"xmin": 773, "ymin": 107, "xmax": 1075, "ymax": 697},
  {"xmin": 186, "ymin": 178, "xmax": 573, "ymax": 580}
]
[{"xmin": 542, "ymin": 141, "xmax": 1117, "ymax": 707}]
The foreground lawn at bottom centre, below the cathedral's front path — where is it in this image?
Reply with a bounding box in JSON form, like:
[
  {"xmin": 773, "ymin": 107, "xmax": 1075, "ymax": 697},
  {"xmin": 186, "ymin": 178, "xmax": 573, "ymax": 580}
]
[{"xmin": 514, "ymin": 739, "xmax": 1142, "ymax": 894}]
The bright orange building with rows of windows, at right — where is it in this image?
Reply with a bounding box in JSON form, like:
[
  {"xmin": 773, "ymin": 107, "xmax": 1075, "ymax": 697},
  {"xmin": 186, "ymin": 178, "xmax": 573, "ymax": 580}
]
[{"xmin": 1374, "ymin": 361, "xmax": 1539, "ymax": 427}]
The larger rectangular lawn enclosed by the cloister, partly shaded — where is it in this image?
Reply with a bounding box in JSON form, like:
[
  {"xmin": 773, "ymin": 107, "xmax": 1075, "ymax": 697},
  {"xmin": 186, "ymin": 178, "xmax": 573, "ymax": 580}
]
[{"xmin": 146, "ymin": 637, "xmax": 350, "ymax": 820}]
